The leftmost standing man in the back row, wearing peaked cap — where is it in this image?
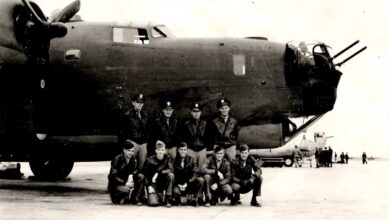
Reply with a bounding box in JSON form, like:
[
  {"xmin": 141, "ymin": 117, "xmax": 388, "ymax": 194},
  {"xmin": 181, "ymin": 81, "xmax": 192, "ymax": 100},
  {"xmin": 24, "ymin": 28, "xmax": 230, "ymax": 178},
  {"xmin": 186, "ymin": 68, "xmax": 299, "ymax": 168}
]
[{"xmin": 119, "ymin": 94, "xmax": 148, "ymax": 170}]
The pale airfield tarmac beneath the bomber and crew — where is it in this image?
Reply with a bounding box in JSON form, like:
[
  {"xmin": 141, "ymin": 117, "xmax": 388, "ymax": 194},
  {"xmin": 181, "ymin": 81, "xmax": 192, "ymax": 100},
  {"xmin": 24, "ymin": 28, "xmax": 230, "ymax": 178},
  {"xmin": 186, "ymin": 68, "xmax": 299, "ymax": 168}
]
[{"xmin": 0, "ymin": 160, "xmax": 390, "ymax": 220}]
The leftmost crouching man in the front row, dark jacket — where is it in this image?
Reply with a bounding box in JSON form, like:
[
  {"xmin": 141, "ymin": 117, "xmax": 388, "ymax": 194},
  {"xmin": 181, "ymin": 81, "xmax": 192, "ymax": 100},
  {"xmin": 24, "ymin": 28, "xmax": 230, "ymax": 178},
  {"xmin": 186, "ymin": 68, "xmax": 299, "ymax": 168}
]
[{"xmin": 107, "ymin": 140, "xmax": 145, "ymax": 205}]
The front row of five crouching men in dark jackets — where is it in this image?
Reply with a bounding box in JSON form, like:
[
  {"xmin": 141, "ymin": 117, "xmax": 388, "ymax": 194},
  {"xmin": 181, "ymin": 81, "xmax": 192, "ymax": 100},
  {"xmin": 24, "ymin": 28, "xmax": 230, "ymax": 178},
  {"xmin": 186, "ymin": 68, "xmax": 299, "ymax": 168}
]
[{"xmin": 108, "ymin": 140, "xmax": 262, "ymax": 207}]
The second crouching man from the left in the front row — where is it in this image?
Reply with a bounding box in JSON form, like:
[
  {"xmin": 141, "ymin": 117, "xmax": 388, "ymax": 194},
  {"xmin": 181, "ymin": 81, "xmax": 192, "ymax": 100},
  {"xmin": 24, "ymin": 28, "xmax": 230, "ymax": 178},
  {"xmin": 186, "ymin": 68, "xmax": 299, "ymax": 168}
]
[{"xmin": 143, "ymin": 141, "xmax": 175, "ymax": 208}]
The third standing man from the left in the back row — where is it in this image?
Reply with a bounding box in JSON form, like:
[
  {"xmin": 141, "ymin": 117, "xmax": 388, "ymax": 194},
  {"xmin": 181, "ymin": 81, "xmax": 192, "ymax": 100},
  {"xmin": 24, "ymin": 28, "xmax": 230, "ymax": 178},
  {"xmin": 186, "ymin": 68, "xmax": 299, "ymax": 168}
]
[{"xmin": 183, "ymin": 103, "xmax": 208, "ymax": 170}]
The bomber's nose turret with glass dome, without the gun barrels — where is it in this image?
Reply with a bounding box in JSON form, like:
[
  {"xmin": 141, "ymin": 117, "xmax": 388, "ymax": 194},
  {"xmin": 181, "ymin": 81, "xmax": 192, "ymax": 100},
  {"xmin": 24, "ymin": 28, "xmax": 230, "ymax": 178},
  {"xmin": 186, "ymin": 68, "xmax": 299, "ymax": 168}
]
[{"xmin": 286, "ymin": 41, "xmax": 342, "ymax": 115}]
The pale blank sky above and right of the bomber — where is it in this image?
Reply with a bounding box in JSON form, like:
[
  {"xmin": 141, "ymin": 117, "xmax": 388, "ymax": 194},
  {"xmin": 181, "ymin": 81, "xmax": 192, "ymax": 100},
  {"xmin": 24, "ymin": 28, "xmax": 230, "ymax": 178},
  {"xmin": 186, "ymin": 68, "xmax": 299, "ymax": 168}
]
[{"xmin": 36, "ymin": 0, "xmax": 390, "ymax": 157}]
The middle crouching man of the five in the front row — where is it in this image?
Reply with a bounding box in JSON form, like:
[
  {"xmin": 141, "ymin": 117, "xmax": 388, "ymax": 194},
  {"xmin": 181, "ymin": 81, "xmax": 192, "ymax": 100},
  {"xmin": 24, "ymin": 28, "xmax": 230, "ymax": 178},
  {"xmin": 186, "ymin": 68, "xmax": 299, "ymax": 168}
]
[{"xmin": 173, "ymin": 142, "xmax": 204, "ymax": 206}]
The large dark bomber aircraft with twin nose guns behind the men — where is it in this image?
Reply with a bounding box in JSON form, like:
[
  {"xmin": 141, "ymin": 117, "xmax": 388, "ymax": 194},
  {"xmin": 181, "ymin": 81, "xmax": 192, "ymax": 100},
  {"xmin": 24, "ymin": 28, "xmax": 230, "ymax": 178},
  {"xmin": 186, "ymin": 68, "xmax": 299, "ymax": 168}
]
[{"xmin": 0, "ymin": 0, "xmax": 364, "ymax": 179}]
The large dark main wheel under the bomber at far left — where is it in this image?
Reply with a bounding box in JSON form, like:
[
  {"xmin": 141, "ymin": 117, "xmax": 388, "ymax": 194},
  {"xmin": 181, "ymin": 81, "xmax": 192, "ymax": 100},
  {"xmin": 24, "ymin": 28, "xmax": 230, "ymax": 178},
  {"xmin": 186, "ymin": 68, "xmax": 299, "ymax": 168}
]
[{"xmin": 29, "ymin": 157, "xmax": 74, "ymax": 180}]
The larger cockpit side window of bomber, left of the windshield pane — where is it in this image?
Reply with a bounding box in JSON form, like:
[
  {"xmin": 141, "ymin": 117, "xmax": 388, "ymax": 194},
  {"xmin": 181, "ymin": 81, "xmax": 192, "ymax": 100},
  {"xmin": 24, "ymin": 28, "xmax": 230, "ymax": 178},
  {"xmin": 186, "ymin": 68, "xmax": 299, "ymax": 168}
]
[{"xmin": 112, "ymin": 27, "xmax": 149, "ymax": 44}]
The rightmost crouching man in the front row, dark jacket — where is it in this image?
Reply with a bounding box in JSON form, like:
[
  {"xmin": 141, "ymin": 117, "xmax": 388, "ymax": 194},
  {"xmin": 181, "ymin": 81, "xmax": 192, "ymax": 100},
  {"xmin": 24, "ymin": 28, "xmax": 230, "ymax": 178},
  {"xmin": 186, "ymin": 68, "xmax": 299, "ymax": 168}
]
[{"xmin": 231, "ymin": 144, "xmax": 263, "ymax": 207}]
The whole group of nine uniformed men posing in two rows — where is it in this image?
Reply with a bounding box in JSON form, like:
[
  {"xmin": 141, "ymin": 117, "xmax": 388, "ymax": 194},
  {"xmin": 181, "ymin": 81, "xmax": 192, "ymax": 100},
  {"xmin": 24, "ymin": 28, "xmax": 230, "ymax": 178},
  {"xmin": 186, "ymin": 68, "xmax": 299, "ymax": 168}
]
[{"xmin": 108, "ymin": 94, "xmax": 261, "ymax": 207}]
